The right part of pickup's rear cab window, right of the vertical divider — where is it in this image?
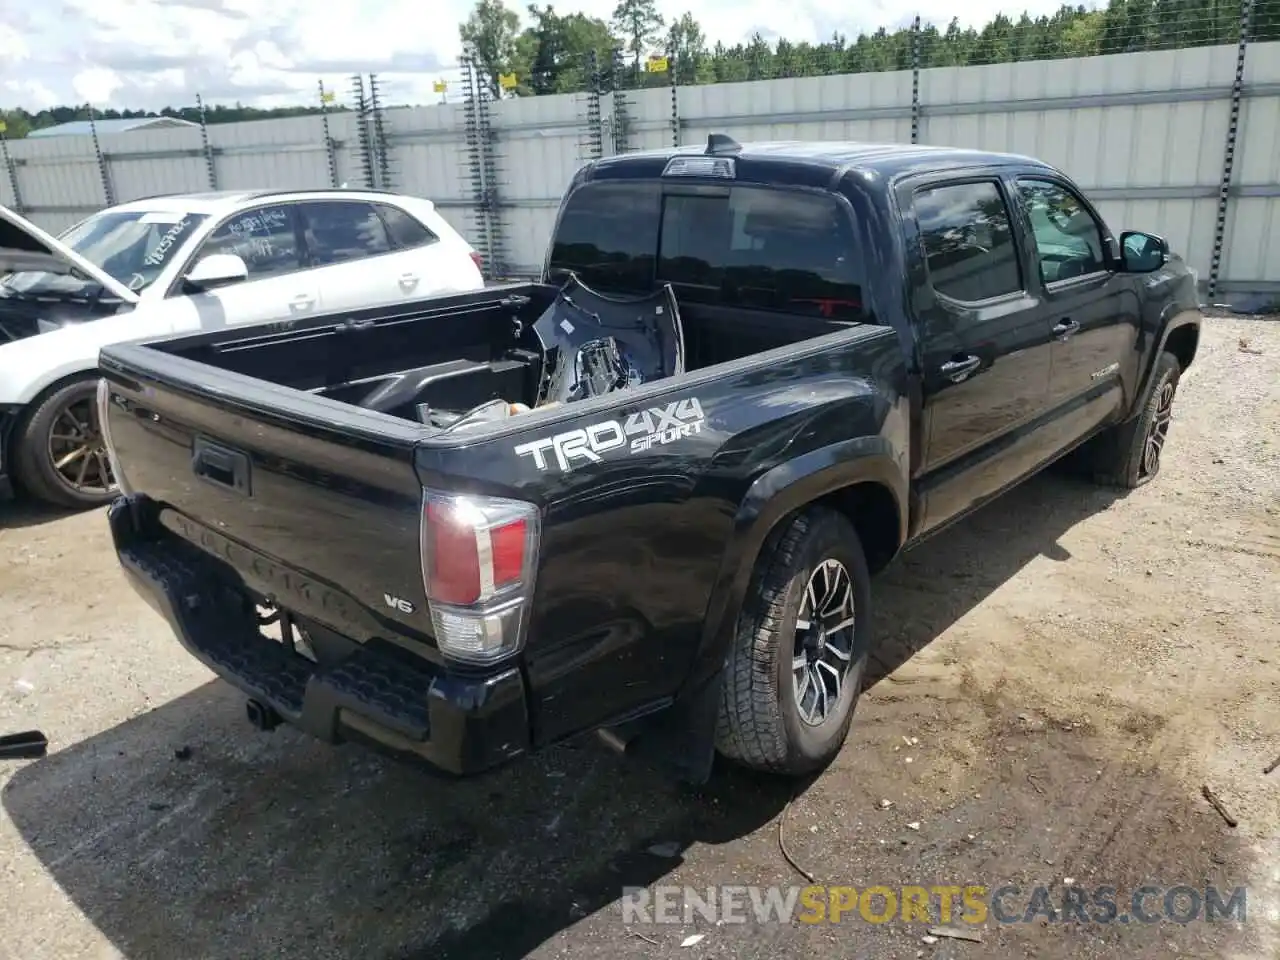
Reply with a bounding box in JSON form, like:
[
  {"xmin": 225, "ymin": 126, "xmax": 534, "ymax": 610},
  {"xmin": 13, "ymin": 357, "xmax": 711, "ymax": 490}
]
[{"xmin": 658, "ymin": 187, "xmax": 864, "ymax": 320}]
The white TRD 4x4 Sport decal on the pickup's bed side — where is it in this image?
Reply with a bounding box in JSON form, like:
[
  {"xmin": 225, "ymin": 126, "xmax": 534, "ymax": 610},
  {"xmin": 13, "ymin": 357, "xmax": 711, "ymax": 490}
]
[{"xmin": 515, "ymin": 397, "xmax": 707, "ymax": 471}]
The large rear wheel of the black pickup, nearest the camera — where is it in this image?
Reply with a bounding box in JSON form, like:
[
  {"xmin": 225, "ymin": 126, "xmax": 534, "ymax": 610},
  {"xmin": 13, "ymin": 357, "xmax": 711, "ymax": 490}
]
[{"xmin": 716, "ymin": 507, "xmax": 870, "ymax": 776}]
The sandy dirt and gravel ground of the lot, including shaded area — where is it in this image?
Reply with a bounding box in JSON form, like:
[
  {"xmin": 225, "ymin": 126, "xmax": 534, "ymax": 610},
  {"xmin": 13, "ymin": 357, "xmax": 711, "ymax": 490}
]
[{"xmin": 0, "ymin": 320, "xmax": 1280, "ymax": 960}]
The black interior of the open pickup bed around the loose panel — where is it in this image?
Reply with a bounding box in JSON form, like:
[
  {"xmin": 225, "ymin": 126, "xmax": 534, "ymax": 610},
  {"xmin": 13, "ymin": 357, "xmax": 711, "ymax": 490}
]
[{"xmin": 140, "ymin": 283, "xmax": 851, "ymax": 424}]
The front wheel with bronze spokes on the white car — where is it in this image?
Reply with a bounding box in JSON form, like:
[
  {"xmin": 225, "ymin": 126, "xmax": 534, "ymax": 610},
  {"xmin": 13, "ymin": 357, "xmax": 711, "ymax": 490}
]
[{"xmin": 13, "ymin": 374, "xmax": 116, "ymax": 509}]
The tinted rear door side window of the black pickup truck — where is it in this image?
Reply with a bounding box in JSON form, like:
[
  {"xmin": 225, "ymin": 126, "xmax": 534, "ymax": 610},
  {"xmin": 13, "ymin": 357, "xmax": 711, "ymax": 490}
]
[{"xmin": 915, "ymin": 180, "xmax": 1023, "ymax": 303}]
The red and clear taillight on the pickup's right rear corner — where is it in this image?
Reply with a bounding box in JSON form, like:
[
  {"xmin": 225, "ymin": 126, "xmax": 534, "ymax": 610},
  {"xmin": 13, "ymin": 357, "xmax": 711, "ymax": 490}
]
[{"xmin": 422, "ymin": 490, "xmax": 541, "ymax": 663}]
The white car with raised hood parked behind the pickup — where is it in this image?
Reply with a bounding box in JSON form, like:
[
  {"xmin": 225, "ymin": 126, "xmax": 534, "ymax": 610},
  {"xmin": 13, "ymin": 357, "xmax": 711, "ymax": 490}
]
[{"xmin": 0, "ymin": 189, "xmax": 484, "ymax": 507}]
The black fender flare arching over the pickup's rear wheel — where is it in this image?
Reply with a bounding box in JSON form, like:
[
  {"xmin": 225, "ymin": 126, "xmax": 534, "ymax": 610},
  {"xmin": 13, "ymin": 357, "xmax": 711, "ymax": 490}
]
[{"xmin": 685, "ymin": 436, "xmax": 908, "ymax": 690}]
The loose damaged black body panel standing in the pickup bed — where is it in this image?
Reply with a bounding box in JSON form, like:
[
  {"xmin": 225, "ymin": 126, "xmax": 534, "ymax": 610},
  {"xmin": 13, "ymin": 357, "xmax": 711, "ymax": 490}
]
[{"xmin": 534, "ymin": 276, "xmax": 685, "ymax": 406}]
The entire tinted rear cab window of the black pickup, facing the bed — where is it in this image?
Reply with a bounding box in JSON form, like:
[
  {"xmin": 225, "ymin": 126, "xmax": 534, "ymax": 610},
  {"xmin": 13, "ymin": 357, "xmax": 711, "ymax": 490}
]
[{"xmin": 548, "ymin": 180, "xmax": 864, "ymax": 320}]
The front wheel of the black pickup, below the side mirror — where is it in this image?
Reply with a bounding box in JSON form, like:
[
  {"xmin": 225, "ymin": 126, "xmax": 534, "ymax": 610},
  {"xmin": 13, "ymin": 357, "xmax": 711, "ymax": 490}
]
[{"xmin": 1087, "ymin": 353, "xmax": 1183, "ymax": 490}]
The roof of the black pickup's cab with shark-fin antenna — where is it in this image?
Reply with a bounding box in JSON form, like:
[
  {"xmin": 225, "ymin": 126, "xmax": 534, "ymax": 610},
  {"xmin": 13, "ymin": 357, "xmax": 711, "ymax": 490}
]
[{"xmin": 594, "ymin": 133, "xmax": 1053, "ymax": 178}]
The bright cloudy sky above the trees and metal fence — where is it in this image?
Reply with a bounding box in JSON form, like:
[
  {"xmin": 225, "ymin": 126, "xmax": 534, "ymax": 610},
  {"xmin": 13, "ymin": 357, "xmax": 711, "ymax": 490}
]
[{"xmin": 0, "ymin": 0, "xmax": 1061, "ymax": 110}]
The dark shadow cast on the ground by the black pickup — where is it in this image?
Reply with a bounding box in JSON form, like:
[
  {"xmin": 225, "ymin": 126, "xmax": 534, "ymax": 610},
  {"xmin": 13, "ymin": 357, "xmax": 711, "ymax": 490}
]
[{"xmin": 3, "ymin": 475, "xmax": 1233, "ymax": 960}]
